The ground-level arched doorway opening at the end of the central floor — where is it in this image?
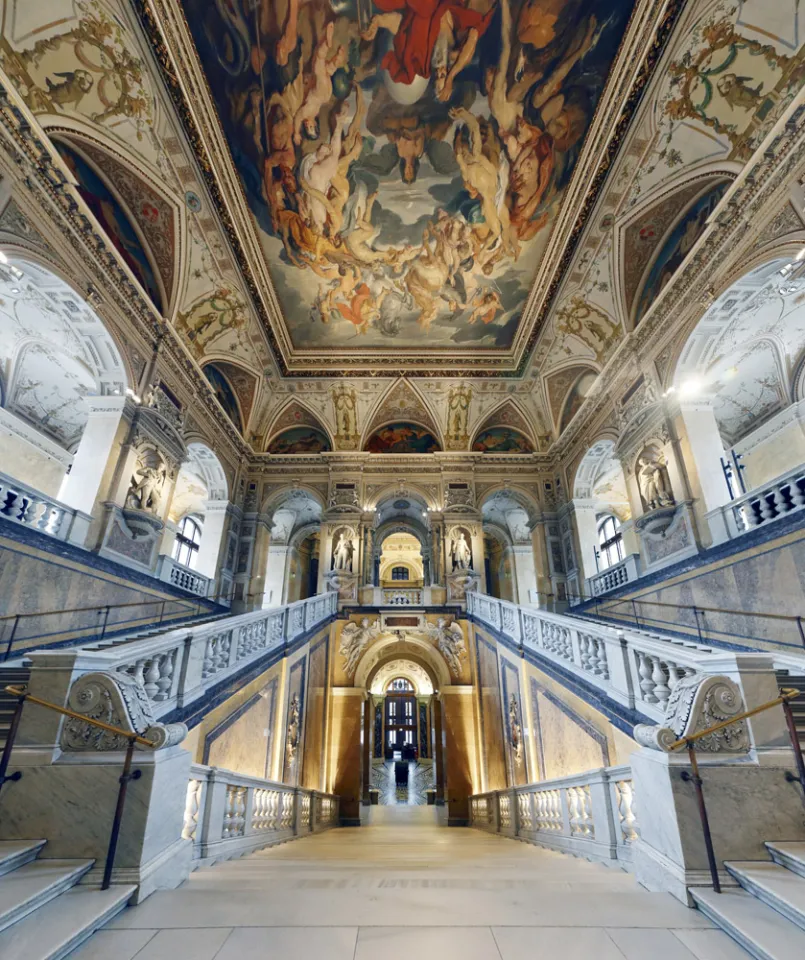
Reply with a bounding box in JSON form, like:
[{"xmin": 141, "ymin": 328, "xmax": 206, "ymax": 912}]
[{"xmin": 365, "ymin": 659, "xmax": 436, "ymax": 806}]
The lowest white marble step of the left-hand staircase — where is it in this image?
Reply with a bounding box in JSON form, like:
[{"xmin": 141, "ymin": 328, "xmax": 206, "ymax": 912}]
[{"xmin": 0, "ymin": 884, "xmax": 137, "ymax": 960}]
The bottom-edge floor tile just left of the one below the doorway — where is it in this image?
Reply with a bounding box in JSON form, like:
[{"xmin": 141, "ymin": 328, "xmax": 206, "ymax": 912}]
[{"xmin": 215, "ymin": 927, "xmax": 358, "ymax": 960}]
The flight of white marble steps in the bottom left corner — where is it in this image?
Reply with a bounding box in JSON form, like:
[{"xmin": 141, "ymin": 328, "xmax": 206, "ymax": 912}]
[{"xmin": 0, "ymin": 840, "xmax": 136, "ymax": 960}]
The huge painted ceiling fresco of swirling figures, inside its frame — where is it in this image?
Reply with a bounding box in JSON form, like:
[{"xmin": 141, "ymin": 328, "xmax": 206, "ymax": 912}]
[{"xmin": 184, "ymin": 0, "xmax": 633, "ymax": 350}]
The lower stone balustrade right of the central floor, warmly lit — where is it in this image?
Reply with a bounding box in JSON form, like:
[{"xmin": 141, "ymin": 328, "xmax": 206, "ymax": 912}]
[{"xmin": 470, "ymin": 766, "xmax": 640, "ymax": 864}]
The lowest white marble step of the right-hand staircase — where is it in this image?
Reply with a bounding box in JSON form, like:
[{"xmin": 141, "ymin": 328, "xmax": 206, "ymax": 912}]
[{"xmin": 690, "ymin": 887, "xmax": 805, "ymax": 960}]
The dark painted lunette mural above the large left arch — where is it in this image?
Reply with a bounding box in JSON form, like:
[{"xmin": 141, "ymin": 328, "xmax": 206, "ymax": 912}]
[{"xmin": 55, "ymin": 140, "xmax": 165, "ymax": 312}]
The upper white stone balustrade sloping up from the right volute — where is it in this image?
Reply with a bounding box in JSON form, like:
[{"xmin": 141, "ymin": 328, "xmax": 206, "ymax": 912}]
[{"xmin": 467, "ymin": 593, "xmax": 805, "ymax": 721}]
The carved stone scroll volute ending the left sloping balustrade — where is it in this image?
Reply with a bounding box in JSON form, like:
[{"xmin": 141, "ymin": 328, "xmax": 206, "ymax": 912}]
[{"xmin": 61, "ymin": 672, "xmax": 187, "ymax": 751}]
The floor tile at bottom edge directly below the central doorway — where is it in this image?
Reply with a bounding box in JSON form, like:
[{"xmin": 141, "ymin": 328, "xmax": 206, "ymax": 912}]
[{"xmin": 355, "ymin": 926, "xmax": 500, "ymax": 960}]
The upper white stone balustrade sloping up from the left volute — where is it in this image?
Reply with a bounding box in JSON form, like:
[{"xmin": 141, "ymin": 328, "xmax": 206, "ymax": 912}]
[{"xmin": 57, "ymin": 593, "xmax": 338, "ymax": 717}]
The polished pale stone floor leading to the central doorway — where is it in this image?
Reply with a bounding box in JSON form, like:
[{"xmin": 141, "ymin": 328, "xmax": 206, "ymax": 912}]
[{"xmin": 71, "ymin": 806, "xmax": 748, "ymax": 960}]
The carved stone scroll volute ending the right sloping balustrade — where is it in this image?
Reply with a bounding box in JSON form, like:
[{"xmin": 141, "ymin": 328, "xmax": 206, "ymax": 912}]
[{"xmin": 634, "ymin": 674, "xmax": 750, "ymax": 753}]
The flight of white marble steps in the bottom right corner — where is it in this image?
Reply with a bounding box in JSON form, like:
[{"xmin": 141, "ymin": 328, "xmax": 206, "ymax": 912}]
[{"xmin": 691, "ymin": 842, "xmax": 805, "ymax": 960}]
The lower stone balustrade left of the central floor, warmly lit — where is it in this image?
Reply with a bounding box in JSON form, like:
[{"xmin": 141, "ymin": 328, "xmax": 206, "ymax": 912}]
[{"xmin": 182, "ymin": 764, "xmax": 338, "ymax": 864}]
